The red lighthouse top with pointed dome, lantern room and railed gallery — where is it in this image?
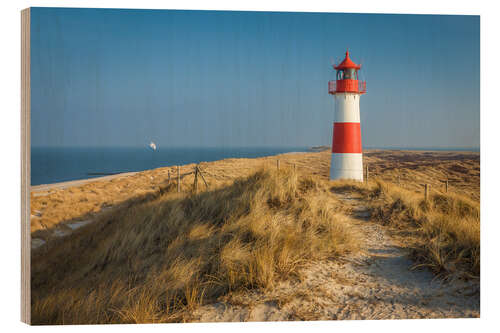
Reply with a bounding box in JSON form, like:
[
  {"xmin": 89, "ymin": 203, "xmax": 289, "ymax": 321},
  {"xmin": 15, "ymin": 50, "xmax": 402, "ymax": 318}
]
[{"xmin": 328, "ymin": 50, "xmax": 366, "ymax": 95}]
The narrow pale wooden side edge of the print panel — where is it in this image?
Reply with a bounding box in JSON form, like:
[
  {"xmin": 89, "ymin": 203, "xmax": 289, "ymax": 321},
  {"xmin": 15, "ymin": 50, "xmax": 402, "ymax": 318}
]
[{"xmin": 21, "ymin": 8, "xmax": 31, "ymax": 324}]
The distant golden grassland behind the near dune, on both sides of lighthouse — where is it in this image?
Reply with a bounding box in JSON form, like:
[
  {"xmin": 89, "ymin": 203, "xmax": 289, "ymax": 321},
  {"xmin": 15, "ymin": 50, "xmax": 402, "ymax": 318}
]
[{"xmin": 30, "ymin": 150, "xmax": 480, "ymax": 235}]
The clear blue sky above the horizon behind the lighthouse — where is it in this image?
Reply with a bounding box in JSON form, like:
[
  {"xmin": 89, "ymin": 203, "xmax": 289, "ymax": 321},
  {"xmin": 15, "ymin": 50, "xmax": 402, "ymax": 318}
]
[{"xmin": 31, "ymin": 8, "xmax": 480, "ymax": 148}]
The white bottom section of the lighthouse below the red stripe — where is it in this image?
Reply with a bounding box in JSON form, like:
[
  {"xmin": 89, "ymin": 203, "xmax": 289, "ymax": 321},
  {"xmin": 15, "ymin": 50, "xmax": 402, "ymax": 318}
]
[{"xmin": 330, "ymin": 153, "xmax": 363, "ymax": 182}]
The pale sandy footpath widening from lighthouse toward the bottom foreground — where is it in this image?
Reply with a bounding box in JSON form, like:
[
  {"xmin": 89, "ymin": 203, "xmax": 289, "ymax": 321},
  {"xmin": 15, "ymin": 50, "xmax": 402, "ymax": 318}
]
[{"xmin": 192, "ymin": 194, "xmax": 479, "ymax": 322}]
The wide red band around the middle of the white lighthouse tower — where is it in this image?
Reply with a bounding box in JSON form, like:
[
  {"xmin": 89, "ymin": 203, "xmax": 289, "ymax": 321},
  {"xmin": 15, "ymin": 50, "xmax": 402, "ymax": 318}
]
[{"xmin": 332, "ymin": 123, "xmax": 362, "ymax": 153}]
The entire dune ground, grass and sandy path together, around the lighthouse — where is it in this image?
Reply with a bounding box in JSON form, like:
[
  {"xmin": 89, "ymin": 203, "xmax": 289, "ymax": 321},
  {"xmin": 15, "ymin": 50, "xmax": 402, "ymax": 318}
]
[{"xmin": 31, "ymin": 151, "xmax": 479, "ymax": 323}]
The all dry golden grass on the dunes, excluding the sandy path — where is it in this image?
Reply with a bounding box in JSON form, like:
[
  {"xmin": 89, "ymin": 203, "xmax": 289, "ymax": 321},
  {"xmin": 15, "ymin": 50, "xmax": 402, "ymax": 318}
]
[{"xmin": 31, "ymin": 151, "xmax": 480, "ymax": 324}]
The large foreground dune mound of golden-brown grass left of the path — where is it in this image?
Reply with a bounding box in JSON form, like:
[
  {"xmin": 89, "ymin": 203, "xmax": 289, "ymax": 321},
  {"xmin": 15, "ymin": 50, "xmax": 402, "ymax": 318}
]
[{"xmin": 31, "ymin": 169, "xmax": 357, "ymax": 324}]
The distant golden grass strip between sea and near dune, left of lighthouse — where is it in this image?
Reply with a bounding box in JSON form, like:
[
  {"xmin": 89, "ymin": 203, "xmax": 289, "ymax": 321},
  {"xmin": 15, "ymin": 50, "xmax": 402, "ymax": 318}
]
[{"xmin": 30, "ymin": 153, "xmax": 329, "ymax": 235}]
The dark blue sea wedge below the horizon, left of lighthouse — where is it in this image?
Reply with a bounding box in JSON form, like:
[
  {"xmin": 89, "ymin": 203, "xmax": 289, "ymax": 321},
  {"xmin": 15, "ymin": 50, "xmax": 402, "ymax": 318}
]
[{"xmin": 31, "ymin": 147, "xmax": 311, "ymax": 185}]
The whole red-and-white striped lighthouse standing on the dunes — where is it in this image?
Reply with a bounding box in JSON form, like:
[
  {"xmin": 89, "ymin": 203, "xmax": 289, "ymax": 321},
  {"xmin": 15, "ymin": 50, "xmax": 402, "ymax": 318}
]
[{"xmin": 328, "ymin": 51, "xmax": 366, "ymax": 181}]
